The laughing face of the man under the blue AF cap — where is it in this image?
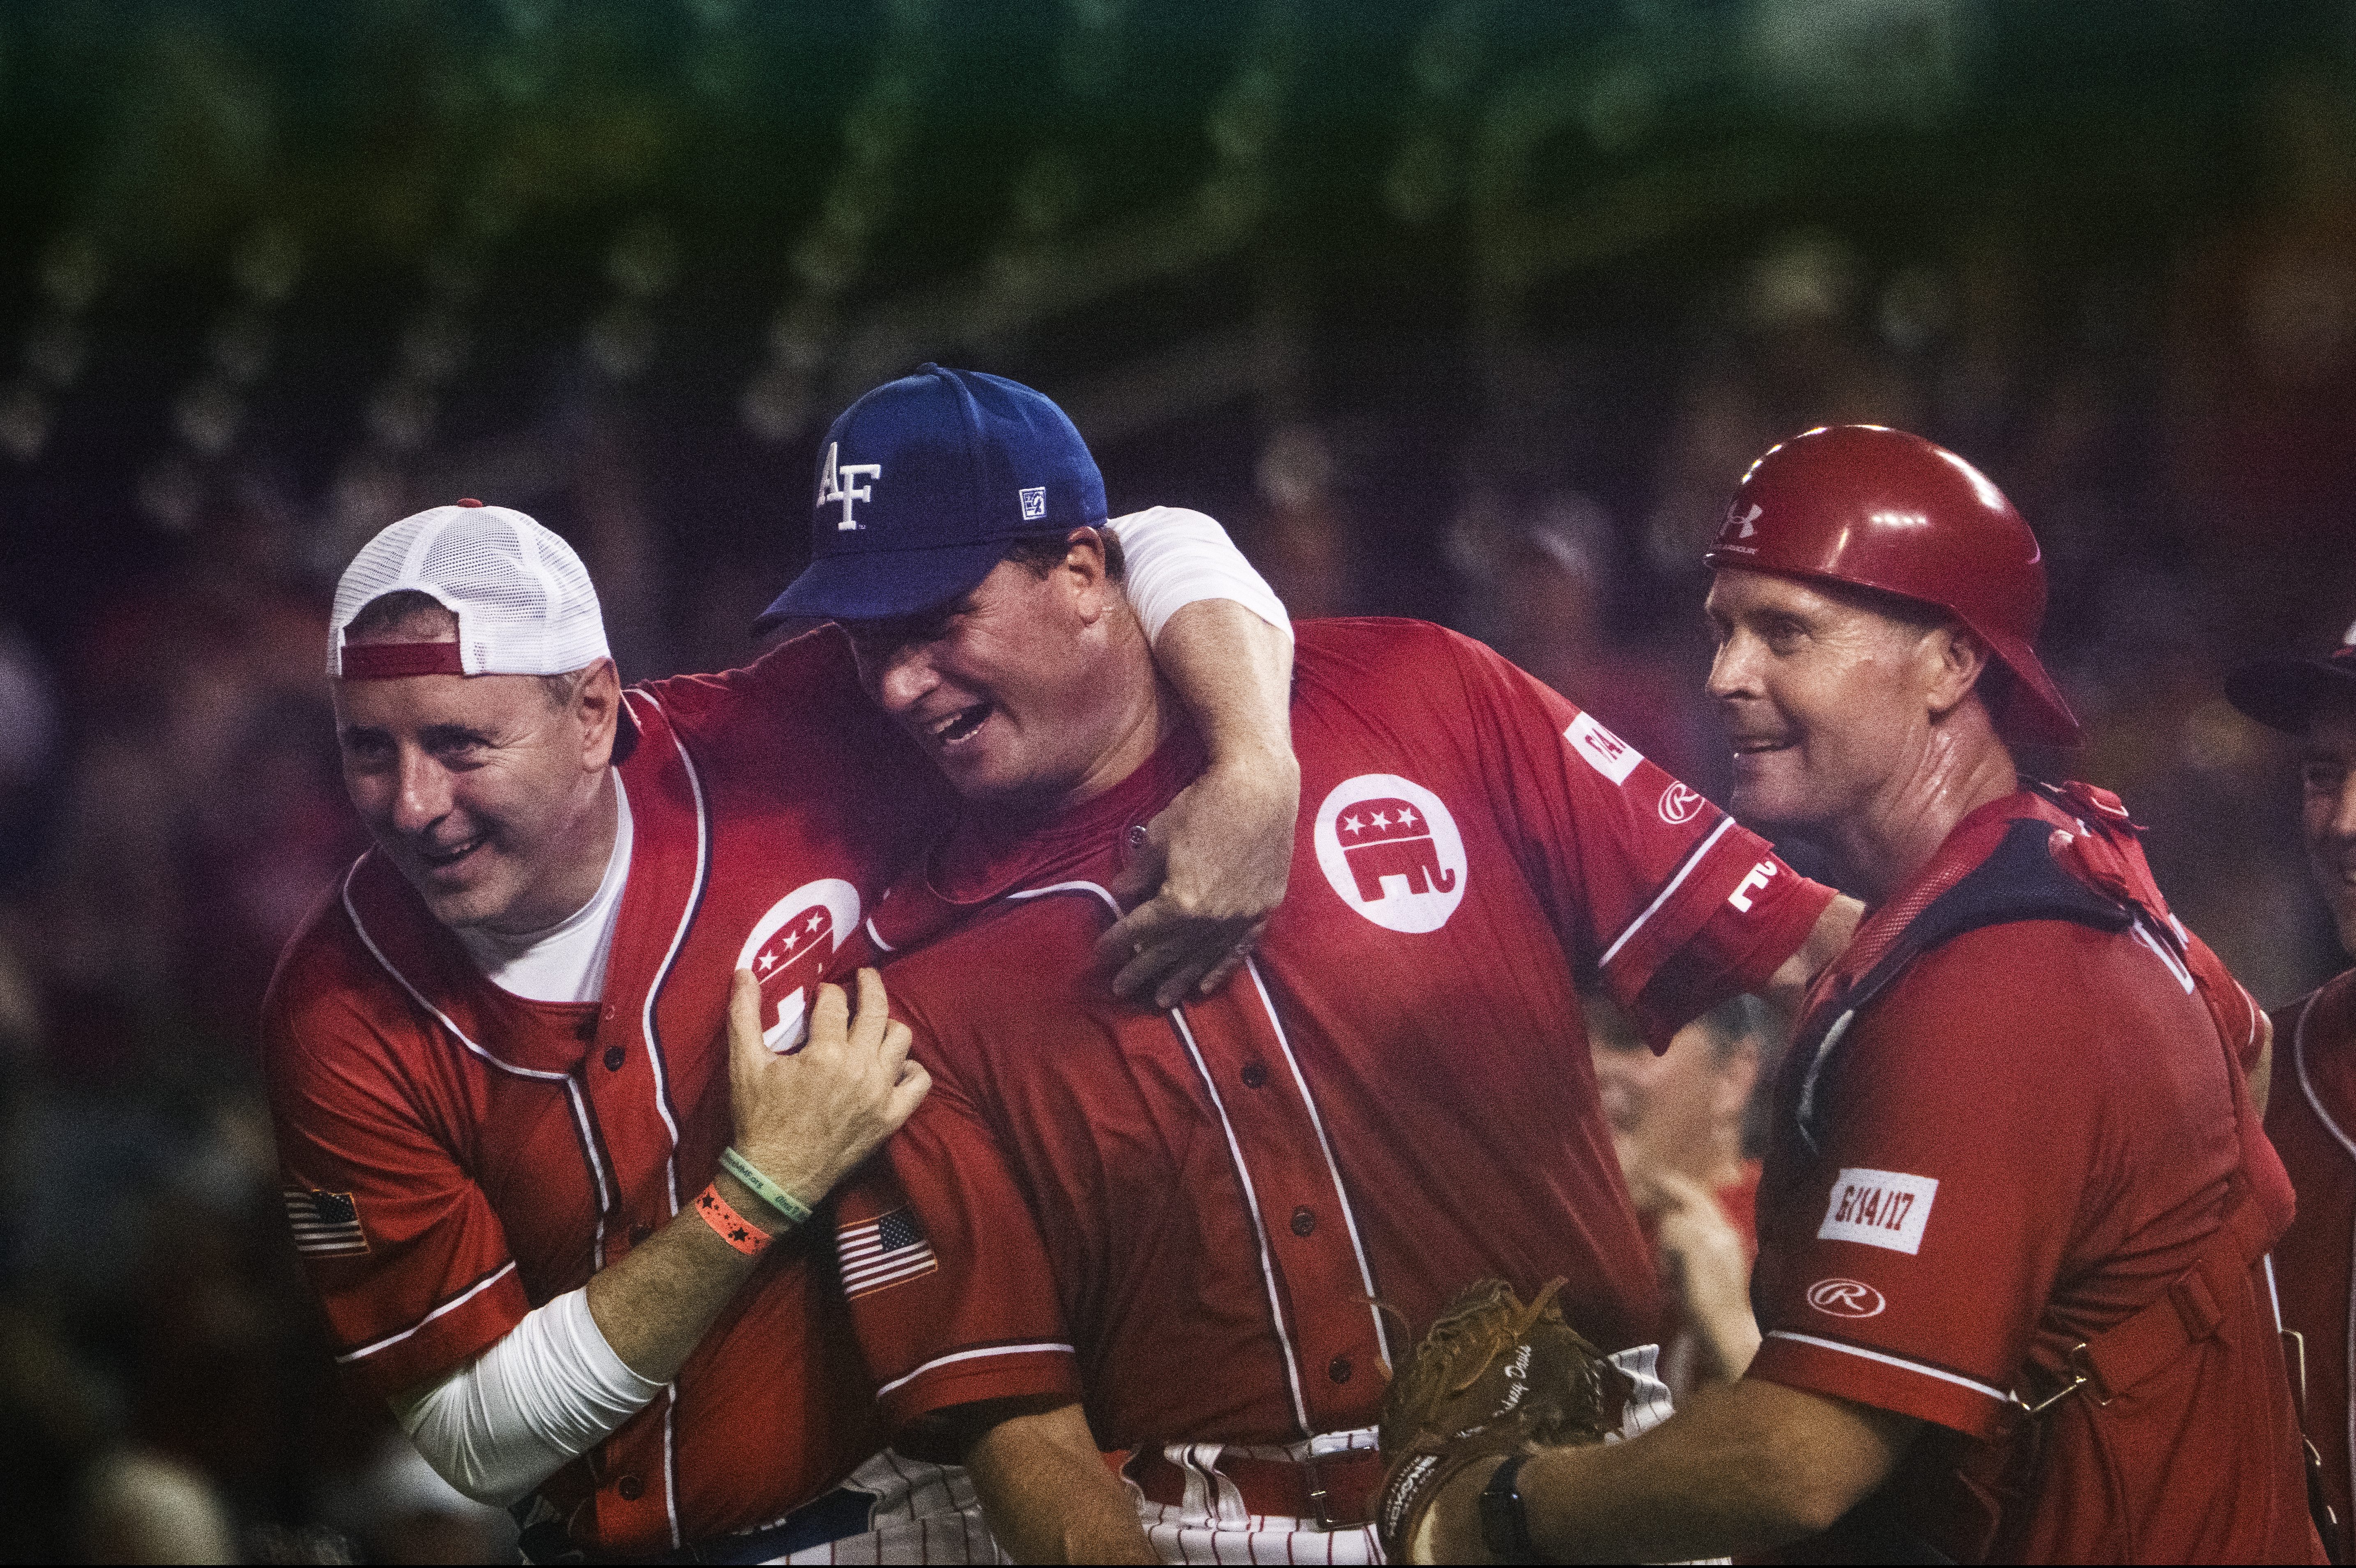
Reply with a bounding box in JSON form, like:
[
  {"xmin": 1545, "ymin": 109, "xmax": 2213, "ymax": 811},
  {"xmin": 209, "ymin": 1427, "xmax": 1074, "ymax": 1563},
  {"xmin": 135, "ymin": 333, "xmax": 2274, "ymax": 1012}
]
[{"xmin": 848, "ymin": 530, "xmax": 1157, "ymax": 815}]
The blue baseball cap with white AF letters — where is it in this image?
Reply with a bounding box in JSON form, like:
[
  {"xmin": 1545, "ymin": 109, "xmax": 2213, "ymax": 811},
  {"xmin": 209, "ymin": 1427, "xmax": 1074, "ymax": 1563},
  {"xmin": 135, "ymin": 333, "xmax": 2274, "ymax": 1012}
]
[{"xmin": 754, "ymin": 365, "xmax": 1105, "ymax": 629}]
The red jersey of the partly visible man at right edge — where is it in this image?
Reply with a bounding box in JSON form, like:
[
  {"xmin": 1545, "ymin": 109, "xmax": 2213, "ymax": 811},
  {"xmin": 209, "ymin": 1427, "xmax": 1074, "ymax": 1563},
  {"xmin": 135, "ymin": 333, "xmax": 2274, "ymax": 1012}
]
[{"xmin": 2266, "ymin": 970, "xmax": 2356, "ymax": 1561}]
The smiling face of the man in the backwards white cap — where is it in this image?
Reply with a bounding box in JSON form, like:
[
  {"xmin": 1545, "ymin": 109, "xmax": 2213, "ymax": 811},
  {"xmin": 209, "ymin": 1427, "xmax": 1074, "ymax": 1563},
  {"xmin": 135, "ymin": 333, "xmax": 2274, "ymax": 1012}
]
[{"xmin": 334, "ymin": 645, "xmax": 617, "ymax": 935}]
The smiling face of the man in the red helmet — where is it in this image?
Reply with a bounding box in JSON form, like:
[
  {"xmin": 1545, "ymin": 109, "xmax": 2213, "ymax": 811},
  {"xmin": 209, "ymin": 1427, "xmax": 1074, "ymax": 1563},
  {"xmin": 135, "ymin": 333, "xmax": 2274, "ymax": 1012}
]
[{"xmin": 1708, "ymin": 567, "xmax": 1944, "ymax": 836}]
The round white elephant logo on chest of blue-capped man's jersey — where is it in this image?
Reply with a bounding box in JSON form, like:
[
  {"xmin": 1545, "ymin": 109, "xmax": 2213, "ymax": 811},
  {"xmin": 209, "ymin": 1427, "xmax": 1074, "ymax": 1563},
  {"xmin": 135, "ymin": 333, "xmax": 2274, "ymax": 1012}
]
[{"xmin": 1315, "ymin": 772, "xmax": 1470, "ymax": 935}]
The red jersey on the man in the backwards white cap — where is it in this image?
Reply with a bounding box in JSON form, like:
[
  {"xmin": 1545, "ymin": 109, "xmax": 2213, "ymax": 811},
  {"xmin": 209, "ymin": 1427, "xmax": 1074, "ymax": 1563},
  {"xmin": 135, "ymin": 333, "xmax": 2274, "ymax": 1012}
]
[{"xmin": 264, "ymin": 631, "xmax": 938, "ymax": 1552}]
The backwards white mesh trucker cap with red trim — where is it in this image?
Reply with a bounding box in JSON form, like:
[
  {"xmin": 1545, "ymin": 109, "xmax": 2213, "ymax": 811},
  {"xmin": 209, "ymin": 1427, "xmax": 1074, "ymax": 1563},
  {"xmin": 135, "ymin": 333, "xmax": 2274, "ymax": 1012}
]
[{"xmin": 327, "ymin": 502, "xmax": 613, "ymax": 680}]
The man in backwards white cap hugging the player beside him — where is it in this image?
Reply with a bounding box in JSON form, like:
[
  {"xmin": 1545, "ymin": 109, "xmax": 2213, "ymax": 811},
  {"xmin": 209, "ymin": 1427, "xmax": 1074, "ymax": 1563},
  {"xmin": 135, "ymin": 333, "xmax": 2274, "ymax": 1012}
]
[{"xmin": 264, "ymin": 482, "xmax": 1289, "ymax": 1561}]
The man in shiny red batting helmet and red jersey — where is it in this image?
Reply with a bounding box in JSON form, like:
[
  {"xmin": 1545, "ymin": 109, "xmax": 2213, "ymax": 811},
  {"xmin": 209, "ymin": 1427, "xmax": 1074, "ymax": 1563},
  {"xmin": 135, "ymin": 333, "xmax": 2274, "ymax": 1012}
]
[{"xmin": 1385, "ymin": 426, "xmax": 2321, "ymax": 1561}]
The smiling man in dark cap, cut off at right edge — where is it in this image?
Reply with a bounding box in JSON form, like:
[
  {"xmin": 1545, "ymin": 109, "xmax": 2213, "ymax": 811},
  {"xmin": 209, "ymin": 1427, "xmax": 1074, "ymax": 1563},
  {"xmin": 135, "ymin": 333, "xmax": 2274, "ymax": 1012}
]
[{"xmin": 2224, "ymin": 626, "xmax": 2356, "ymax": 1563}]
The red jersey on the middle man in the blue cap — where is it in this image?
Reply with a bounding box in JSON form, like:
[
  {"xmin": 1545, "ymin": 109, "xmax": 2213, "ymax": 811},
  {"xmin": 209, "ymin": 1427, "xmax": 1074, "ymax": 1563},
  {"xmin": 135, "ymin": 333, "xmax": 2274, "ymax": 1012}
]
[{"xmin": 841, "ymin": 619, "xmax": 1831, "ymax": 1448}]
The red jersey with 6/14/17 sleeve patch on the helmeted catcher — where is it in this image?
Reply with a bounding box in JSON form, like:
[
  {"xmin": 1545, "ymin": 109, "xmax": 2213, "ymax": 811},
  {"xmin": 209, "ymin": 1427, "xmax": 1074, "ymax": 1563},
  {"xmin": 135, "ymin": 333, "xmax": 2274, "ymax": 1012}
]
[{"xmin": 1750, "ymin": 793, "xmax": 2314, "ymax": 1561}]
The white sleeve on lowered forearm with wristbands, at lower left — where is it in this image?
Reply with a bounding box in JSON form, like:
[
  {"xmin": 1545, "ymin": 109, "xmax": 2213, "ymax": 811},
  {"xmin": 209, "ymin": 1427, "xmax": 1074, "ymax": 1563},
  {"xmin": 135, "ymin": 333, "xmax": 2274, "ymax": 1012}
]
[{"xmin": 394, "ymin": 1290, "xmax": 662, "ymax": 1507}]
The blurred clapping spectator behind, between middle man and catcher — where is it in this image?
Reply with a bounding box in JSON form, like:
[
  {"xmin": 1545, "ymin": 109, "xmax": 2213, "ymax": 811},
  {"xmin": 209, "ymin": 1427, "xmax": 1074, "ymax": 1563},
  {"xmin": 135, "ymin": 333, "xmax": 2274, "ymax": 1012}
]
[{"xmin": 1586, "ymin": 996, "xmax": 1769, "ymax": 1401}]
